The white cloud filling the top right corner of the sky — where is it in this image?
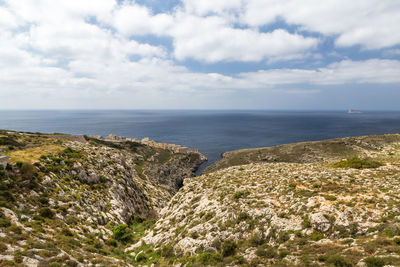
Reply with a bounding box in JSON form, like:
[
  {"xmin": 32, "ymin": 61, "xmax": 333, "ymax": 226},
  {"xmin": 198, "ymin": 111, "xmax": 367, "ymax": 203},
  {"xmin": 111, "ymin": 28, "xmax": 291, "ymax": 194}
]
[{"xmin": 239, "ymin": 0, "xmax": 400, "ymax": 49}]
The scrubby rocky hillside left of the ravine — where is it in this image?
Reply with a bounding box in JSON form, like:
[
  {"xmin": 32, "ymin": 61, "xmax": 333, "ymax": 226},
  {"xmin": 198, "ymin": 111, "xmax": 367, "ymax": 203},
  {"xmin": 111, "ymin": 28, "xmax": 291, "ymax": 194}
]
[{"xmin": 0, "ymin": 131, "xmax": 203, "ymax": 266}]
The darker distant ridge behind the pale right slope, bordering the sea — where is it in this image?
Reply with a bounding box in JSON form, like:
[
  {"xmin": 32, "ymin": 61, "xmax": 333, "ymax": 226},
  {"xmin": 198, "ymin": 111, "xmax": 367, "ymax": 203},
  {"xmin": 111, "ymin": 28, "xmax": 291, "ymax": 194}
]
[{"xmin": 204, "ymin": 134, "xmax": 400, "ymax": 173}]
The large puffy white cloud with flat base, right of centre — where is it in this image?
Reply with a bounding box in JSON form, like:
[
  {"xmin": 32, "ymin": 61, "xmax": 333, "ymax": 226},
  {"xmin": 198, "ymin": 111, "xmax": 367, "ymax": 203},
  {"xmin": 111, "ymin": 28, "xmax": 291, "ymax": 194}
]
[{"xmin": 171, "ymin": 15, "xmax": 318, "ymax": 62}]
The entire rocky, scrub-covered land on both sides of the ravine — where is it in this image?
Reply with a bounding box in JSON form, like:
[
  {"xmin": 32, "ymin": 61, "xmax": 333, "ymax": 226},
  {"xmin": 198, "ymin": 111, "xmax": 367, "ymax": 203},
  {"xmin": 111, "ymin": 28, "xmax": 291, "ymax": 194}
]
[{"xmin": 0, "ymin": 131, "xmax": 400, "ymax": 267}]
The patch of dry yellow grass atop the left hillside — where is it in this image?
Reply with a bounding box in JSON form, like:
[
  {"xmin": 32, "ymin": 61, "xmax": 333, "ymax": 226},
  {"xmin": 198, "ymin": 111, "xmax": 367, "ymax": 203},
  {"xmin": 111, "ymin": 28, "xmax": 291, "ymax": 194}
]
[{"xmin": 8, "ymin": 145, "xmax": 65, "ymax": 163}]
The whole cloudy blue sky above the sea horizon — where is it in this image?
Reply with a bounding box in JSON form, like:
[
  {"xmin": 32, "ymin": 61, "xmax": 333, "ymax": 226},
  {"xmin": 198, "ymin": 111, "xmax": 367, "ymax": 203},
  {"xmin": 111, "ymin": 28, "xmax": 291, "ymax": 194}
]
[{"xmin": 0, "ymin": 0, "xmax": 400, "ymax": 110}]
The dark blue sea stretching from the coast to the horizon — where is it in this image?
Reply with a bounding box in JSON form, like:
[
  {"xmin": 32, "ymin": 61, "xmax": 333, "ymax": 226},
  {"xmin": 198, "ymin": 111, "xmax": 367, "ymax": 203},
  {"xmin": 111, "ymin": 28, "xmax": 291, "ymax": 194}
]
[{"xmin": 0, "ymin": 110, "xmax": 400, "ymax": 173}]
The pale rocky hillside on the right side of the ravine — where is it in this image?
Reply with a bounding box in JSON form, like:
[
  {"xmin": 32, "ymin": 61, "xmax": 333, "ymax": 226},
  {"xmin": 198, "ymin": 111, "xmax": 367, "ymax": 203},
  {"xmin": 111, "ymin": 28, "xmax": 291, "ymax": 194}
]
[{"xmin": 127, "ymin": 135, "xmax": 400, "ymax": 266}]
